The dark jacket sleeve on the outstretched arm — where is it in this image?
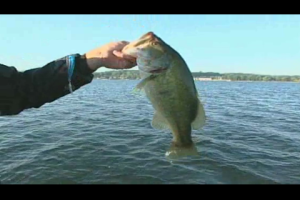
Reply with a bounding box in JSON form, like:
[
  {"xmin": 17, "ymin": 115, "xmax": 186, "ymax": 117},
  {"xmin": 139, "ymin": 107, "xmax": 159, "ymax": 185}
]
[{"xmin": 0, "ymin": 54, "xmax": 94, "ymax": 116}]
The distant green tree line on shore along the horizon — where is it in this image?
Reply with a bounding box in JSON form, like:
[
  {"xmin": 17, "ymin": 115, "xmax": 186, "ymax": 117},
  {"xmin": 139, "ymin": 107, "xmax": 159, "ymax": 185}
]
[{"xmin": 94, "ymin": 70, "xmax": 300, "ymax": 82}]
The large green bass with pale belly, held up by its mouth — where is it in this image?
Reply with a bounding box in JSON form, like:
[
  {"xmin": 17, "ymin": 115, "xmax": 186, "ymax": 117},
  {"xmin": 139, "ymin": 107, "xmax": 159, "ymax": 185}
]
[{"xmin": 122, "ymin": 31, "xmax": 206, "ymax": 159}]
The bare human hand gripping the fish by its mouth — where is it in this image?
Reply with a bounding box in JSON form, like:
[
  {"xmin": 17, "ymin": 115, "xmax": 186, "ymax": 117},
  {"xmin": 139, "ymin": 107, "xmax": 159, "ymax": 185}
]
[{"xmin": 85, "ymin": 41, "xmax": 137, "ymax": 70}]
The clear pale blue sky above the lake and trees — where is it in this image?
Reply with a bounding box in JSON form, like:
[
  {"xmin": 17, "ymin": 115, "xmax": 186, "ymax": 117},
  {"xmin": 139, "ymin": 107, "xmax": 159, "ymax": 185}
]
[{"xmin": 0, "ymin": 14, "xmax": 300, "ymax": 75}]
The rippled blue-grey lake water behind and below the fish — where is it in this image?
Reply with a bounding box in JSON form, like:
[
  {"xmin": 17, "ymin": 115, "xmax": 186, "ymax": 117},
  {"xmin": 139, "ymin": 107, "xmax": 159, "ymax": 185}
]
[{"xmin": 0, "ymin": 80, "xmax": 300, "ymax": 184}]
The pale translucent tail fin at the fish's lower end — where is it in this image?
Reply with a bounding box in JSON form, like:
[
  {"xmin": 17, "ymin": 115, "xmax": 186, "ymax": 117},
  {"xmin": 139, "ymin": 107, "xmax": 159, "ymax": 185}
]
[{"xmin": 165, "ymin": 142, "xmax": 199, "ymax": 160}]
